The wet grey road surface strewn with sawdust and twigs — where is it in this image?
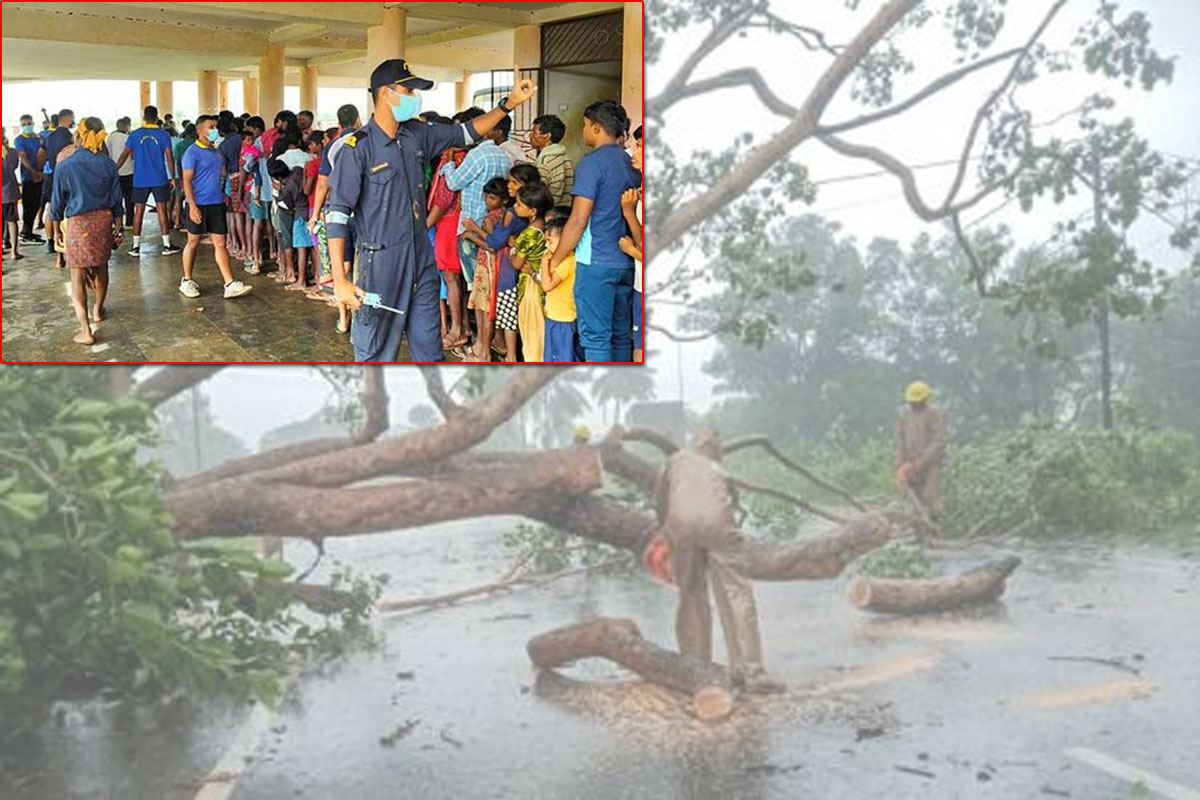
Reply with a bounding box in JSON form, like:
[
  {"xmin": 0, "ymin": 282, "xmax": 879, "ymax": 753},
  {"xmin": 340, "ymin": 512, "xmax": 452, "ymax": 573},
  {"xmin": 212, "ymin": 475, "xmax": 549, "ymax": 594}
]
[{"xmin": 4, "ymin": 521, "xmax": 1200, "ymax": 800}]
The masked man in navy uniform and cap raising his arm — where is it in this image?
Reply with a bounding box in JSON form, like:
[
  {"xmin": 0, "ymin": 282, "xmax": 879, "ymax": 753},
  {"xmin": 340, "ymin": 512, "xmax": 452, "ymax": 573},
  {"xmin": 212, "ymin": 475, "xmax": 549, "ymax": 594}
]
[{"xmin": 325, "ymin": 59, "xmax": 535, "ymax": 362}]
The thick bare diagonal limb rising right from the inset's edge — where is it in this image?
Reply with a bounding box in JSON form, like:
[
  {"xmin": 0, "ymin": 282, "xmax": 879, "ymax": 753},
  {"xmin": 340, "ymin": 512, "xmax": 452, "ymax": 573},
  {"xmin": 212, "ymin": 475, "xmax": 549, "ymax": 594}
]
[{"xmin": 649, "ymin": 0, "xmax": 920, "ymax": 260}]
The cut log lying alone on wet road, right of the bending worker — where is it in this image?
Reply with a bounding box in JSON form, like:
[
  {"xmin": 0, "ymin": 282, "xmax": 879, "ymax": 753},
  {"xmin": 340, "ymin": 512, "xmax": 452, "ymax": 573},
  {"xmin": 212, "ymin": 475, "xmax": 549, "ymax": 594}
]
[{"xmin": 850, "ymin": 555, "xmax": 1021, "ymax": 614}]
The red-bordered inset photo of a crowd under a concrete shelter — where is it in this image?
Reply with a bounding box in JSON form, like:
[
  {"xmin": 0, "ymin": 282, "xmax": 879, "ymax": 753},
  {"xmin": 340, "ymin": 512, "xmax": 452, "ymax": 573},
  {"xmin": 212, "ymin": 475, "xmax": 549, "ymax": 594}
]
[{"xmin": 0, "ymin": 2, "xmax": 644, "ymax": 363}]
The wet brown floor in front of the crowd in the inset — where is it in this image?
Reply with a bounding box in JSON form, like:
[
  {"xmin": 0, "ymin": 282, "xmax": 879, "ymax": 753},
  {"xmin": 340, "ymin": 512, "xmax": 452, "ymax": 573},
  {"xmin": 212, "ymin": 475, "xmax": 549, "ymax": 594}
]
[{"xmin": 2, "ymin": 213, "xmax": 427, "ymax": 362}]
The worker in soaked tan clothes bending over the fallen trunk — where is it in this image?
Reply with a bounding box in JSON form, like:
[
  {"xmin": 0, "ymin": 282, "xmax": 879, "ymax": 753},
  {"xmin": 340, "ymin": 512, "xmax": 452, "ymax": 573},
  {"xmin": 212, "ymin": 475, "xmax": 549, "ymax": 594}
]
[{"xmin": 643, "ymin": 428, "xmax": 782, "ymax": 692}]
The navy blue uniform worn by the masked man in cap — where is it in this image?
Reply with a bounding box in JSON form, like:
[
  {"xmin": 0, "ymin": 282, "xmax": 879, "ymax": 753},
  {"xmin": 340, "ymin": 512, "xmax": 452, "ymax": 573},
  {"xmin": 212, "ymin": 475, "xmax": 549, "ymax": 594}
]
[{"xmin": 325, "ymin": 120, "xmax": 480, "ymax": 362}]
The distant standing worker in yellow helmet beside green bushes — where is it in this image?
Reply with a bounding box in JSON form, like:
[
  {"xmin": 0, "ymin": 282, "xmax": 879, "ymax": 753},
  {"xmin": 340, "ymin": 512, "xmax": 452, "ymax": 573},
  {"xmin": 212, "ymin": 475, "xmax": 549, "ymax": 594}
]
[{"xmin": 896, "ymin": 380, "xmax": 946, "ymax": 522}]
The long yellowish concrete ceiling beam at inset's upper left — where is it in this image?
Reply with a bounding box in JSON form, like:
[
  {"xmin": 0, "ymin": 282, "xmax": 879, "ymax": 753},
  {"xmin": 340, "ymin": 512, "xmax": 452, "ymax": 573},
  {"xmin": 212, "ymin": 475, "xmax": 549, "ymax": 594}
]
[{"xmin": 4, "ymin": 4, "xmax": 268, "ymax": 56}]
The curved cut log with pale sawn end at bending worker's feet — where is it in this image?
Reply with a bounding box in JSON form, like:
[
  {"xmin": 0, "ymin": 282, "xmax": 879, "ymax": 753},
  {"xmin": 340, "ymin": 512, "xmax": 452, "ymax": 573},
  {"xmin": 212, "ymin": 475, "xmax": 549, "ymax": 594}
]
[{"xmin": 526, "ymin": 616, "xmax": 733, "ymax": 722}]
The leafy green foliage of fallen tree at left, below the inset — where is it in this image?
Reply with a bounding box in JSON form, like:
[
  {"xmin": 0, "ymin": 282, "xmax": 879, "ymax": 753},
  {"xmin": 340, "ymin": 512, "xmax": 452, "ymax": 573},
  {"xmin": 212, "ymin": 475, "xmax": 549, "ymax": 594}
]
[{"xmin": 0, "ymin": 368, "xmax": 371, "ymax": 719}]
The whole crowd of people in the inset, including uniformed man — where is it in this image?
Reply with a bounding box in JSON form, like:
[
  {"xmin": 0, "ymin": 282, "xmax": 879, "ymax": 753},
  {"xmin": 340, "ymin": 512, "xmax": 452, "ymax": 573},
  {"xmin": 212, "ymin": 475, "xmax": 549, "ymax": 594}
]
[{"xmin": 4, "ymin": 60, "xmax": 642, "ymax": 362}]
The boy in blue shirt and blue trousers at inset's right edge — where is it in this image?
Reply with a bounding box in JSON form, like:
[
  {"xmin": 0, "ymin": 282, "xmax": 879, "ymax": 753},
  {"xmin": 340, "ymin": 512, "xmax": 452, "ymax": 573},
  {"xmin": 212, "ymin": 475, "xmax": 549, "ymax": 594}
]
[{"xmin": 550, "ymin": 100, "xmax": 642, "ymax": 362}]
